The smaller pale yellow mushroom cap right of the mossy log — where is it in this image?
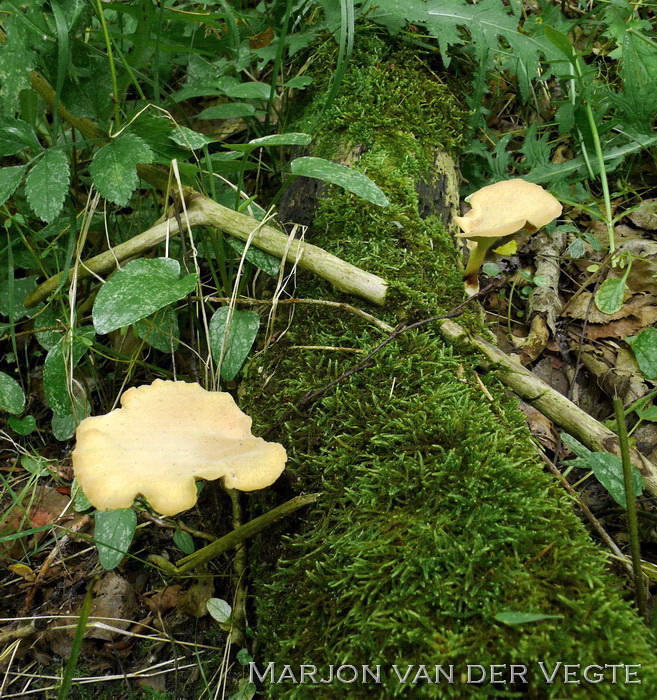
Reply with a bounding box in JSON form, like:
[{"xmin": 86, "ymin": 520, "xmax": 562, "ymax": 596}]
[{"xmin": 454, "ymin": 178, "xmax": 563, "ymax": 240}]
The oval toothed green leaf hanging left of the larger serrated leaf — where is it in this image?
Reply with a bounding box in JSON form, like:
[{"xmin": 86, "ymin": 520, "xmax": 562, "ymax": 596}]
[{"xmin": 25, "ymin": 148, "xmax": 71, "ymax": 223}]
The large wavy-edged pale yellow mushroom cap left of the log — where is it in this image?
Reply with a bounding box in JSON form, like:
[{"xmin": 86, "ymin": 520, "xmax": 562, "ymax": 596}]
[{"xmin": 73, "ymin": 379, "xmax": 287, "ymax": 515}]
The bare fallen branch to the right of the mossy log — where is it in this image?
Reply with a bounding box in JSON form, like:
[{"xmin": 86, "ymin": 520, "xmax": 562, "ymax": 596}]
[{"xmin": 439, "ymin": 319, "xmax": 657, "ymax": 495}]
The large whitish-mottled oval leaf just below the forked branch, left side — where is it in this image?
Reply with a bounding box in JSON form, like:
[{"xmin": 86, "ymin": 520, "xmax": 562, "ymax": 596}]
[{"xmin": 93, "ymin": 258, "xmax": 198, "ymax": 335}]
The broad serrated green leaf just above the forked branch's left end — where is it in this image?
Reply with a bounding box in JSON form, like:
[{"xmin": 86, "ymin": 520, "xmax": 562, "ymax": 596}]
[{"xmin": 89, "ymin": 133, "xmax": 153, "ymax": 207}]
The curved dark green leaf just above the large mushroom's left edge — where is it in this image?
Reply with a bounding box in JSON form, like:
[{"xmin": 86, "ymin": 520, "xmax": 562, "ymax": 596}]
[{"xmin": 43, "ymin": 326, "xmax": 94, "ymax": 418}]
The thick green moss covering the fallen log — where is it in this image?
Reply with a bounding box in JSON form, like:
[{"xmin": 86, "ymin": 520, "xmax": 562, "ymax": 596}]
[{"xmin": 245, "ymin": 39, "xmax": 657, "ymax": 698}]
